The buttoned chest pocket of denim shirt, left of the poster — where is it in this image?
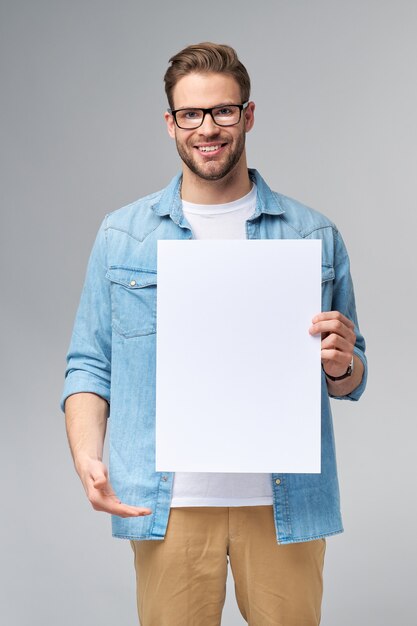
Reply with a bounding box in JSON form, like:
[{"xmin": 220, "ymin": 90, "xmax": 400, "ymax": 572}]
[{"xmin": 106, "ymin": 267, "xmax": 157, "ymax": 338}]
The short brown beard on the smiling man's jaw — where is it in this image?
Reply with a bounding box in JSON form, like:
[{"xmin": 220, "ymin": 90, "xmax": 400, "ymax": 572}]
[{"xmin": 175, "ymin": 132, "xmax": 246, "ymax": 180}]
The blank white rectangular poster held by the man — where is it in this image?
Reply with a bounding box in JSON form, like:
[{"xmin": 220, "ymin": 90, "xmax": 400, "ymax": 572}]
[{"xmin": 156, "ymin": 240, "xmax": 321, "ymax": 473}]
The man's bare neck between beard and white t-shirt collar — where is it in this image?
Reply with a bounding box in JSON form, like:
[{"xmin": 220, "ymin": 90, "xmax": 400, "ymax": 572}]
[{"xmin": 181, "ymin": 155, "xmax": 252, "ymax": 204}]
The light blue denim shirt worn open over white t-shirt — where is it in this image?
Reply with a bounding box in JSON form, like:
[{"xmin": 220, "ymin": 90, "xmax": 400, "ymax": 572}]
[{"xmin": 62, "ymin": 170, "xmax": 367, "ymax": 544}]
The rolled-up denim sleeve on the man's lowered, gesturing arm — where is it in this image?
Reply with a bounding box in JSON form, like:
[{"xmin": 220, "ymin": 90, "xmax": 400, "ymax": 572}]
[{"xmin": 61, "ymin": 219, "xmax": 111, "ymax": 410}]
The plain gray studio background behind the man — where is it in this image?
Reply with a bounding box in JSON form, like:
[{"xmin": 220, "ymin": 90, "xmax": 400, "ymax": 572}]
[{"xmin": 0, "ymin": 0, "xmax": 417, "ymax": 626}]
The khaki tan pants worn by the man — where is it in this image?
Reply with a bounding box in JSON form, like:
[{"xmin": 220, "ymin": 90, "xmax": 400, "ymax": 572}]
[{"xmin": 131, "ymin": 506, "xmax": 325, "ymax": 626}]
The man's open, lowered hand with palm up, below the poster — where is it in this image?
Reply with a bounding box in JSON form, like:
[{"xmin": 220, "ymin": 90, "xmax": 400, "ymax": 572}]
[{"xmin": 79, "ymin": 460, "xmax": 152, "ymax": 517}]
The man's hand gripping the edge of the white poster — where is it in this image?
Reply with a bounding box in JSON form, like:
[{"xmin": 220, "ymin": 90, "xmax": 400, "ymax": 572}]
[{"xmin": 309, "ymin": 311, "xmax": 356, "ymax": 376}]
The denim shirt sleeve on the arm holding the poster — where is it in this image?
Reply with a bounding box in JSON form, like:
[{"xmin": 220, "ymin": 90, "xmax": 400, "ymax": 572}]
[{"xmin": 330, "ymin": 231, "xmax": 368, "ymax": 400}]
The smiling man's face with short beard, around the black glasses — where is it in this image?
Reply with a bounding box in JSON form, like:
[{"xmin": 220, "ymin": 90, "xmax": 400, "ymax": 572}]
[{"xmin": 165, "ymin": 73, "xmax": 255, "ymax": 180}]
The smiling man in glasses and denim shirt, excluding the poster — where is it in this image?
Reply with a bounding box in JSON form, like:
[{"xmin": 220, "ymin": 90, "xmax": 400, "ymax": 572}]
[{"xmin": 63, "ymin": 43, "xmax": 366, "ymax": 626}]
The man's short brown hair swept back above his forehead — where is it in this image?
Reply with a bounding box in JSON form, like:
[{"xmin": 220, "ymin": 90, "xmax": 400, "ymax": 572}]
[{"xmin": 164, "ymin": 41, "xmax": 250, "ymax": 108}]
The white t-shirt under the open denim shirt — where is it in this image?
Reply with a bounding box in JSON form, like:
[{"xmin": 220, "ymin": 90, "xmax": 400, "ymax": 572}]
[{"xmin": 171, "ymin": 185, "xmax": 272, "ymax": 507}]
